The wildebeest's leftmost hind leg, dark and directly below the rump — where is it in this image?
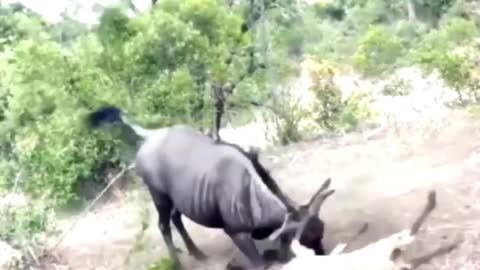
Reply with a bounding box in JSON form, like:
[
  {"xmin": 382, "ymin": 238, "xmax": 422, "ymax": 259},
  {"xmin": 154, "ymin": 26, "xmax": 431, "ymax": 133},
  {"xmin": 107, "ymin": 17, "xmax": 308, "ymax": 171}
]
[{"xmin": 150, "ymin": 191, "xmax": 183, "ymax": 270}]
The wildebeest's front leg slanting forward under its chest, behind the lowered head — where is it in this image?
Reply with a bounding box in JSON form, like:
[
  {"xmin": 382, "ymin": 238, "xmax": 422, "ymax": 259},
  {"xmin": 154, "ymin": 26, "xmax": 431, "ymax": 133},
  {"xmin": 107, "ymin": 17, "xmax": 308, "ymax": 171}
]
[{"xmin": 227, "ymin": 232, "xmax": 267, "ymax": 270}]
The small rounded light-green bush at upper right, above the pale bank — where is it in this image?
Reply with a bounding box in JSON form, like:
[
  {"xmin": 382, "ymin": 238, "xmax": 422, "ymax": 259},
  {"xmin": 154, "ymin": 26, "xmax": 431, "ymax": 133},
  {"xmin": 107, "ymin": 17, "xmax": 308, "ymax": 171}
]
[{"xmin": 353, "ymin": 25, "xmax": 404, "ymax": 76}]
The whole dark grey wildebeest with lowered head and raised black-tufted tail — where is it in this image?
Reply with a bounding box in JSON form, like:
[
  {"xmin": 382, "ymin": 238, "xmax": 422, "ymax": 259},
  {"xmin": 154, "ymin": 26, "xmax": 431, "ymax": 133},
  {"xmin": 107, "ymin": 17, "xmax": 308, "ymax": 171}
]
[{"xmin": 88, "ymin": 106, "xmax": 330, "ymax": 269}]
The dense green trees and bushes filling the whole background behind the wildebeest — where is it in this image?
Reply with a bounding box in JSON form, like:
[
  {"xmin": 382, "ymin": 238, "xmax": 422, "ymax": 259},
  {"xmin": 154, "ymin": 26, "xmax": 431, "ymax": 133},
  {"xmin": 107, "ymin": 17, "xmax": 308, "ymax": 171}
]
[{"xmin": 0, "ymin": 0, "xmax": 480, "ymax": 268}]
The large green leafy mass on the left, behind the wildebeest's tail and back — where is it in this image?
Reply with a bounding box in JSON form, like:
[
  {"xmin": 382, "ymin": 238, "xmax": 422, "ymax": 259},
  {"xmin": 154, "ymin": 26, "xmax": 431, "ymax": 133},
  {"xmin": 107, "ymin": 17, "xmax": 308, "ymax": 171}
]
[{"xmin": 0, "ymin": 0, "xmax": 256, "ymax": 209}]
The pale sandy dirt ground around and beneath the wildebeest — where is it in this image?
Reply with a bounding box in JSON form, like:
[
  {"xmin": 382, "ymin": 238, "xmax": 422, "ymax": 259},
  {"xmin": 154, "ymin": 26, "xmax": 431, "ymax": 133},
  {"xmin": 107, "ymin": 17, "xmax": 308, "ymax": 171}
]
[{"xmin": 44, "ymin": 109, "xmax": 480, "ymax": 270}]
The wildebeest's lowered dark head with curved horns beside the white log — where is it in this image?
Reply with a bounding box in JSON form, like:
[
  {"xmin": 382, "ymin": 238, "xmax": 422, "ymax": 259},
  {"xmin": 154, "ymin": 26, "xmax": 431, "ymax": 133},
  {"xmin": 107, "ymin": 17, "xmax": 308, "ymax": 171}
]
[{"xmin": 270, "ymin": 178, "xmax": 335, "ymax": 255}]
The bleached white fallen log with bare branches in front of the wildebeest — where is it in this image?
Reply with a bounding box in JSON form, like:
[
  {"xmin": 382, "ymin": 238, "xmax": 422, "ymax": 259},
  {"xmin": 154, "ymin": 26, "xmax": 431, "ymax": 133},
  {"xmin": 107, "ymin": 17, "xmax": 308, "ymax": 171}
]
[{"xmin": 281, "ymin": 191, "xmax": 460, "ymax": 270}]
